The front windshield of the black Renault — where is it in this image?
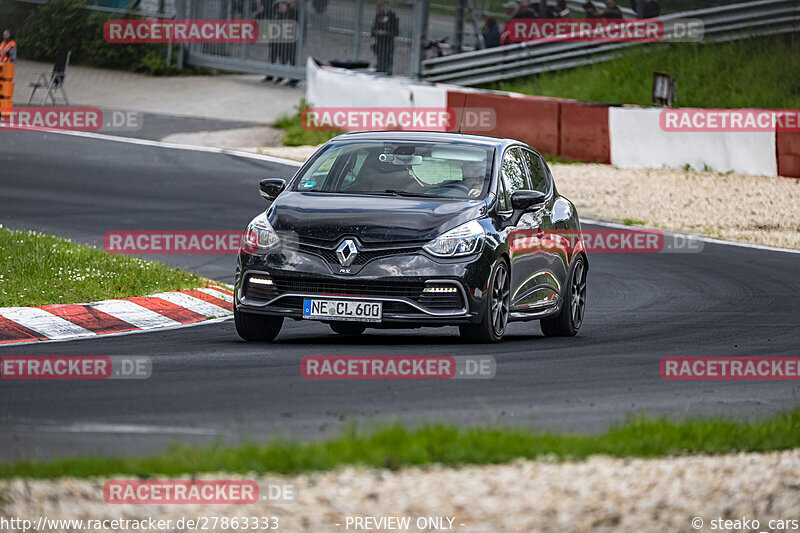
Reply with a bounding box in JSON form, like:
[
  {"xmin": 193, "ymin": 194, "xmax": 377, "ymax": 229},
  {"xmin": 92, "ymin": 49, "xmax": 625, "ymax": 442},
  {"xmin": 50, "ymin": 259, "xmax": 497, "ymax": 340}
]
[{"xmin": 294, "ymin": 142, "xmax": 494, "ymax": 199}]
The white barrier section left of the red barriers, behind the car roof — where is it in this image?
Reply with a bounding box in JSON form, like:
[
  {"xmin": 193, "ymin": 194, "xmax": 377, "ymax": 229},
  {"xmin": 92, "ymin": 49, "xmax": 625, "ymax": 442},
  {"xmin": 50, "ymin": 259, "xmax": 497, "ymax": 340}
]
[{"xmin": 306, "ymin": 58, "xmax": 447, "ymax": 108}]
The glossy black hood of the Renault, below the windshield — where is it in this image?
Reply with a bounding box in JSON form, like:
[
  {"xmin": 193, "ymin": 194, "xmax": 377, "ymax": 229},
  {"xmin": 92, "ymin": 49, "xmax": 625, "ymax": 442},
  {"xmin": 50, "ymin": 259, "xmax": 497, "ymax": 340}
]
[{"xmin": 267, "ymin": 191, "xmax": 484, "ymax": 243}]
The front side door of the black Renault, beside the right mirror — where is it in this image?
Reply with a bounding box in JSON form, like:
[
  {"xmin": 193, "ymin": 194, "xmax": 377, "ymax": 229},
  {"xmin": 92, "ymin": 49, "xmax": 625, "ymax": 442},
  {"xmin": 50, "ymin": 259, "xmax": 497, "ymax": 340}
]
[{"xmin": 498, "ymin": 146, "xmax": 553, "ymax": 312}]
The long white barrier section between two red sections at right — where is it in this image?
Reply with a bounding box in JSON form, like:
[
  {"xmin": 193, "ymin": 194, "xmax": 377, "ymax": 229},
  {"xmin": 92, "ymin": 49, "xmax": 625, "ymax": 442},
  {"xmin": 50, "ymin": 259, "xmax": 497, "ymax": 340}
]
[{"xmin": 608, "ymin": 107, "xmax": 778, "ymax": 176}]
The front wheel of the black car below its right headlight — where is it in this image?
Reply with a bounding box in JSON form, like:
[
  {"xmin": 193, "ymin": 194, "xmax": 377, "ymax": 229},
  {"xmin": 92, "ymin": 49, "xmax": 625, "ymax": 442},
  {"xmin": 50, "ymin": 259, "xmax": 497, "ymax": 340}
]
[{"xmin": 458, "ymin": 260, "xmax": 511, "ymax": 344}]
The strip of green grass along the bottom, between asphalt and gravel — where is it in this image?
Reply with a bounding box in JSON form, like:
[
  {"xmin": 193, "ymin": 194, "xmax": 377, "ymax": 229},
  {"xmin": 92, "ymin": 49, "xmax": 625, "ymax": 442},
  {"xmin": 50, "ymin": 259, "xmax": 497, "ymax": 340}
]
[{"xmin": 0, "ymin": 409, "xmax": 800, "ymax": 478}]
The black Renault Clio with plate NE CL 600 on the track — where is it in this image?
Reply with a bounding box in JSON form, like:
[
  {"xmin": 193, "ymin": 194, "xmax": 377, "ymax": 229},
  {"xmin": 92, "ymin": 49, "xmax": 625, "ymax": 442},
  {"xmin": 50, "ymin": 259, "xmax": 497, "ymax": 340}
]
[{"xmin": 234, "ymin": 132, "xmax": 588, "ymax": 342}]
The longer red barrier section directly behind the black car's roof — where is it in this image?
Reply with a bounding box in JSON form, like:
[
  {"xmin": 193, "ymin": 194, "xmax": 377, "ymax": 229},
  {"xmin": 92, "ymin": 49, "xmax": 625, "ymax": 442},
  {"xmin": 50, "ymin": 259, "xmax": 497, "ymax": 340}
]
[{"xmin": 447, "ymin": 90, "xmax": 564, "ymax": 154}]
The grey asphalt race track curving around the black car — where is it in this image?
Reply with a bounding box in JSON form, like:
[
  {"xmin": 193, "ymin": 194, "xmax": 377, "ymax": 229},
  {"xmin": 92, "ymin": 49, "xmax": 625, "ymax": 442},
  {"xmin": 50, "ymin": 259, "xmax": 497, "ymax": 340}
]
[{"xmin": 0, "ymin": 132, "xmax": 800, "ymax": 459}]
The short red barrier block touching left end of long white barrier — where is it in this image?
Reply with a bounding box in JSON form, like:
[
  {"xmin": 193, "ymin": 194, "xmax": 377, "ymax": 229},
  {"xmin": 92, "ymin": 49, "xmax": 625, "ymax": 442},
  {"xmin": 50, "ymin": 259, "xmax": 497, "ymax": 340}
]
[{"xmin": 558, "ymin": 101, "xmax": 611, "ymax": 163}]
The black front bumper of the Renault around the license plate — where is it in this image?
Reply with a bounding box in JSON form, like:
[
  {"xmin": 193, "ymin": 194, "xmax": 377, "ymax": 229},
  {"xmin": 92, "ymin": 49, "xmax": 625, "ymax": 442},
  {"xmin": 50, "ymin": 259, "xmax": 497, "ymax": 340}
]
[{"xmin": 235, "ymin": 247, "xmax": 491, "ymax": 327}]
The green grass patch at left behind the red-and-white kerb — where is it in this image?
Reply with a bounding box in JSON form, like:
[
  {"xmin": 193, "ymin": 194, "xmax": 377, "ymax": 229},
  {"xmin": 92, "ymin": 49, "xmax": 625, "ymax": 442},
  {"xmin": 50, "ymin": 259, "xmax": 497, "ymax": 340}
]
[{"xmin": 0, "ymin": 228, "xmax": 205, "ymax": 307}]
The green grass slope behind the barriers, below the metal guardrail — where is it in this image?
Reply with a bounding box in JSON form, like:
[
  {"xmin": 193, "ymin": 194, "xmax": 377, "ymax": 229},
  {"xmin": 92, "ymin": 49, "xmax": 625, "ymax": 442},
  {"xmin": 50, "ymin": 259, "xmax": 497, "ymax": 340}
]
[{"xmin": 489, "ymin": 35, "xmax": 800, "ymax": 109}]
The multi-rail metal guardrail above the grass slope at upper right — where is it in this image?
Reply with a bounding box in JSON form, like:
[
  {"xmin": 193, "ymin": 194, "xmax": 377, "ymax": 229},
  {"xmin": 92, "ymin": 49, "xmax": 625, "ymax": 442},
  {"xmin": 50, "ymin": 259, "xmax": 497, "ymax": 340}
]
[{"xmin": 422, "ymin": 0, "xmax": 800, "ymax": 85}]
